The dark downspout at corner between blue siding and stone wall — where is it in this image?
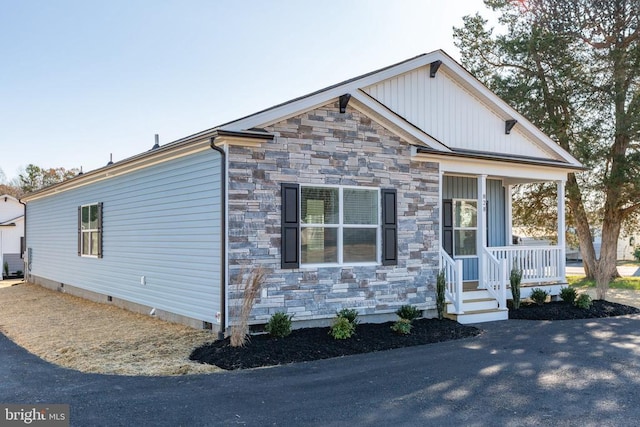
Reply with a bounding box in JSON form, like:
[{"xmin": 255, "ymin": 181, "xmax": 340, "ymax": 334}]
[{"xmin": 209, "ymin": 135, "xmax": 227, "ymax": 340}]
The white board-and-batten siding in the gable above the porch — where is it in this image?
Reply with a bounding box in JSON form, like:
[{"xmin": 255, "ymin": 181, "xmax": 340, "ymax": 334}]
[{"xmin": 364, "ymin": 66, "xmax": 557, "ymax": 159}]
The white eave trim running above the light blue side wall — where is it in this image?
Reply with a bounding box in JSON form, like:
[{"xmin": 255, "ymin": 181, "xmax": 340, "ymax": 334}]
[{"xmin": 22, "ymin": 138, "xmax": 211, "ymax": 202}]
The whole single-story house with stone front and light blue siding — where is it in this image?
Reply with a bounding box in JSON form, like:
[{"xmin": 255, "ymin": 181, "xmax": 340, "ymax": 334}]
[{"xmin": 23, "ymin": 51, "xmax": 582, "ymax": 331}]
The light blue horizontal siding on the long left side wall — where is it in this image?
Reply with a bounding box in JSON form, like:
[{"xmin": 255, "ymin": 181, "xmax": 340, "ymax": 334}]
[{"xmin": 27, "ymin": 151, "xmax": 221, "ymax": 323}]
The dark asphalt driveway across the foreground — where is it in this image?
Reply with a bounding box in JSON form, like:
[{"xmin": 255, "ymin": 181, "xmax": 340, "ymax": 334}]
[{"xmin": 0, "ymin": 316, "xmax": 640, "ymax": 426}]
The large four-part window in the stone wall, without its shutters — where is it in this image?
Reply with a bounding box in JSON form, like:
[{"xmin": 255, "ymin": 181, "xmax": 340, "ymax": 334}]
[{"xmin": 300, "ymin": 187, "xmax": 380, "ymax": 264}]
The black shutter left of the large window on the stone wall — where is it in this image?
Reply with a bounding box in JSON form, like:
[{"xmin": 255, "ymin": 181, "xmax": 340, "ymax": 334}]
[{"xmin": 280, "ymin": 183, "xmax": 300, "ymax": 269}]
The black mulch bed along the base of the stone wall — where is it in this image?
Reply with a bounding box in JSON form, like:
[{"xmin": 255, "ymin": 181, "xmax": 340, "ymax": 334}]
[{"xmin": 189, "ymin": 319, "xmax": 482, "ymax": 369}]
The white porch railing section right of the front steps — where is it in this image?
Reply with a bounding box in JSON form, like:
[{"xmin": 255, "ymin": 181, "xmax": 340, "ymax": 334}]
[{"xmin": 487, "ymin": 246, "xmax": 565, "ymax": 283}]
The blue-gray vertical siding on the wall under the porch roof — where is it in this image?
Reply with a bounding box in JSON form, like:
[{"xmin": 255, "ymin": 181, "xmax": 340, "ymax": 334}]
[{"xmin": 442, "ymin": 176, "xmax": 505, "ymax": 280}]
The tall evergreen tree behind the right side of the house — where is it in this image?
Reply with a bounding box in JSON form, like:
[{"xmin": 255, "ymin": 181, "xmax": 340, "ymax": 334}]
[{"xmin": 454, "ymin": 0, "xmax": 640, "ymax": 299}]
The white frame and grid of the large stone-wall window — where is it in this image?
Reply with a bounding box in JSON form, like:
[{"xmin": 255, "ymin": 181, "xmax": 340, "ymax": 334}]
[{"xmin": 298, "ymin": 184, "xmax": 382, "ymax": 267}]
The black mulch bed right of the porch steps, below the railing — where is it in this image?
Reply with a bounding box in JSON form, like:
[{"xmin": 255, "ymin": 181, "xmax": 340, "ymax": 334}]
[{"xmin": 509, "ymin": 300, "xmax": 640, "ymax": 320}]
